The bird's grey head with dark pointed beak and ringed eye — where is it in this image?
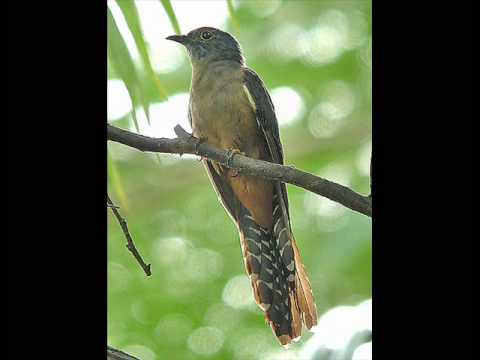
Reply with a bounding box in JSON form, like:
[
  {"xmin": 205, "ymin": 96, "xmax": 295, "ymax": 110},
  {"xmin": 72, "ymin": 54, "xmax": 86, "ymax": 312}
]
[{"xmin": 167, "ymin": 27, "xmax": 244, "ymax": 66}]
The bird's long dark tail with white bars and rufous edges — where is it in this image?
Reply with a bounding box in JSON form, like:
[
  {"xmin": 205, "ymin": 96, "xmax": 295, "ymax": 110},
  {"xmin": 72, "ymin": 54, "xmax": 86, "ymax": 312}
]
[{"xmin": 237, "ymin": 199, "xmax": 317, "ymax": 345}]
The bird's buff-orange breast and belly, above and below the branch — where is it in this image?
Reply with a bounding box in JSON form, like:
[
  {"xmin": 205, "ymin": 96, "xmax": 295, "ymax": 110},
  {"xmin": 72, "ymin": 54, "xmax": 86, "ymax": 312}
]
[{"xmin": 190, "ymin": 67, "xmax": 273, "ymax": 229}]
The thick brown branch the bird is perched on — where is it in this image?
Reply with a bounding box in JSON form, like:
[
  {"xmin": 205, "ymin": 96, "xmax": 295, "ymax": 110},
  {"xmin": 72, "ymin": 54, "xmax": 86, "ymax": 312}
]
[{"xmin": 107, "ymin": 124, "xmax": 372, "ymax": 217}]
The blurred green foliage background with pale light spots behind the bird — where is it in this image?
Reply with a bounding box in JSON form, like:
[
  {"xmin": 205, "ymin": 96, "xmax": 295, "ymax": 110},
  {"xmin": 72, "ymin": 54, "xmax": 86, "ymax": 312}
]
[{"xmin": 108, "ymin": 0, "xmax": 372, "ymax": 360}]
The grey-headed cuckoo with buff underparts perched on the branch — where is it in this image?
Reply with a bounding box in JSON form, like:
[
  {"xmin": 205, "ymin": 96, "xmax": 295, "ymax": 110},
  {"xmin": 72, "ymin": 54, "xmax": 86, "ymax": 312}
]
[{"xmin": 166, "ymin": 27, "xmax": 317, "ymax": 347}]
